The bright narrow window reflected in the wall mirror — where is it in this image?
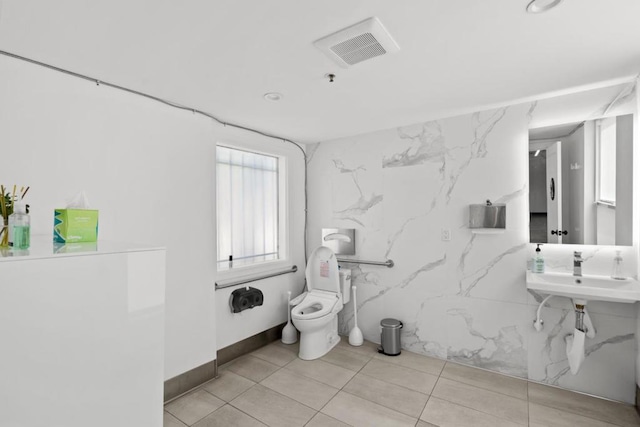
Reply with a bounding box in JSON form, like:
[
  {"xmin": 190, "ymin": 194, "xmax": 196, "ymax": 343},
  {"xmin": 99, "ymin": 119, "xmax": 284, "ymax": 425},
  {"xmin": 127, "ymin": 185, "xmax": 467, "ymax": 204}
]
[{"xmin": 596, "ymin": 117, "xmax": 616, "ymax": 206}]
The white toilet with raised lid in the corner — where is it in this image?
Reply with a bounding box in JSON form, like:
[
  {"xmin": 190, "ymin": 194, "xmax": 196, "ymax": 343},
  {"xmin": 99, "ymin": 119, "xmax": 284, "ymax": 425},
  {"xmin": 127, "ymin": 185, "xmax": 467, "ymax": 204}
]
[{"xmin": 291, "ymin": 246, "xmax": 351, "ymax": 360}]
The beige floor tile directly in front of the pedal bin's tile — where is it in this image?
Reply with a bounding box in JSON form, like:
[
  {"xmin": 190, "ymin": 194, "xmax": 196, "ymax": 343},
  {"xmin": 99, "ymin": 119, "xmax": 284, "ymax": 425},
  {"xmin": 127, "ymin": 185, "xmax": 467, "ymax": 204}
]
[{"xmin": 360, "ymin": 359, "xmax": 438, "ymax": 394}]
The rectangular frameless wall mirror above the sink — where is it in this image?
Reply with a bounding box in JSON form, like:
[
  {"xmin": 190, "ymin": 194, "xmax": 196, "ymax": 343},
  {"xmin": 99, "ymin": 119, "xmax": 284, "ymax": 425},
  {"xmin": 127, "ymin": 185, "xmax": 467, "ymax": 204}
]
[{"xmin": 529, "ymin": 114, "xmax": 633, "ymax": 246}]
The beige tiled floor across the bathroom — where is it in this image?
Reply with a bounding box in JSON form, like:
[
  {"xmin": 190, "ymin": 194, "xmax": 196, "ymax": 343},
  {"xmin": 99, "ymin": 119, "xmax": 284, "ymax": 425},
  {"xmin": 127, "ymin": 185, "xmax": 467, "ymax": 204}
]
[{"xmin": 164, "ymin": 337, "xmax": 640, "ymax": 427}]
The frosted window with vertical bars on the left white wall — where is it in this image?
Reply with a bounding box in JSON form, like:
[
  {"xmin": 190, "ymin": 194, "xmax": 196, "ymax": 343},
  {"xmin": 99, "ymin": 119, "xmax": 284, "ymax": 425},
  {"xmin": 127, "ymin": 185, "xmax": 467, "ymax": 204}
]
[{"xmin": 216, "ymin": 145, "xmax": 281, "ymax": 270}]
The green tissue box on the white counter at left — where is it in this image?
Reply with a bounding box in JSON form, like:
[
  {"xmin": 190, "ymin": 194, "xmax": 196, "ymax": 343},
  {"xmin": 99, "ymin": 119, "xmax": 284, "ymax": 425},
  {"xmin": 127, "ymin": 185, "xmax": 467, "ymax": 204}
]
[{"xmin": 53, "ymin": 209, "xmax": 98, "ymax": 243}]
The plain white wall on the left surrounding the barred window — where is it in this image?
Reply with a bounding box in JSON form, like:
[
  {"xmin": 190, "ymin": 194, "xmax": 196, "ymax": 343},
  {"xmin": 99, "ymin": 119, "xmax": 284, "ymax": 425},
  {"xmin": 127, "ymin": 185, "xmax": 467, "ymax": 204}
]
[{"xmin": 0, "ymin": 56, "xmax": 304, "ymax": 379}]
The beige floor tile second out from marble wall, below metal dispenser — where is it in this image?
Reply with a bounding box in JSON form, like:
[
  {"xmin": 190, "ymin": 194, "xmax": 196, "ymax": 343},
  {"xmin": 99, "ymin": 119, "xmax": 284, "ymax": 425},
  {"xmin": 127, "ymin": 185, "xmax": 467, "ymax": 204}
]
[{"xmin": 432, "ymin": 377, "xmax": 528, "ymax": 425}]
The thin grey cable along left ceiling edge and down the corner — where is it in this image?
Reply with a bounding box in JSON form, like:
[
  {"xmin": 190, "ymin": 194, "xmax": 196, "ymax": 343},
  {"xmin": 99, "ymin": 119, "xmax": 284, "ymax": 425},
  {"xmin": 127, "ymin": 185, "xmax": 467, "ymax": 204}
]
[{"xmin": 0, "ymin": 49, "xmax": 307, "ymax": 264}]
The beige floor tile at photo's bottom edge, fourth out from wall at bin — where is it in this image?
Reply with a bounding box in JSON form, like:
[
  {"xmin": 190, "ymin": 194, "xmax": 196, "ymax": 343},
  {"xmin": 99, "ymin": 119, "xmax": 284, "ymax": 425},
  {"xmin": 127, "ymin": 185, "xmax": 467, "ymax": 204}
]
[{"xmin": 321, "ymin": 391, "xmax": 417, "ymax": 427}]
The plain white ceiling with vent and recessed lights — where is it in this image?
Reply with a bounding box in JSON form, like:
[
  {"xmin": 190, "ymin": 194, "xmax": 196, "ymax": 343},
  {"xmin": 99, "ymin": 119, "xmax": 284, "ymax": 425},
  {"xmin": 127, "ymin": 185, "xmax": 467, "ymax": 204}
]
[{"xmin": 0, "ymin": 0, "xmax": 640, "ymax": 142}]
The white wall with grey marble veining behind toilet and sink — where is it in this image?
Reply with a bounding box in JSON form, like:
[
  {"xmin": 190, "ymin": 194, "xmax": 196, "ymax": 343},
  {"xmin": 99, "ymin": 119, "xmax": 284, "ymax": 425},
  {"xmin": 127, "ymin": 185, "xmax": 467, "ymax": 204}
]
[{"xmin": 309, "ymin": 83, "xmax": 637, "ymax": 402}]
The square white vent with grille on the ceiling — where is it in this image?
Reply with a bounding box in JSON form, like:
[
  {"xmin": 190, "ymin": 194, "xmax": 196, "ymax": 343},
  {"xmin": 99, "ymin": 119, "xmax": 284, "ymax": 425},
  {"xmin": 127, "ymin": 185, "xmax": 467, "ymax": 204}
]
[{"xmin": 313, "ymin": 17, "xmax": 400, "ymax": 68}]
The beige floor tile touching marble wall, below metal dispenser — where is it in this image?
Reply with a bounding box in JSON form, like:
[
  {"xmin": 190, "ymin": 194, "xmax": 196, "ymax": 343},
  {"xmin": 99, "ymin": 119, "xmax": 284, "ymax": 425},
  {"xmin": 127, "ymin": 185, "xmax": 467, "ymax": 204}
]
[{"xmin": 441, "ymin": 362, "xmax": 527, "ymax": 400}]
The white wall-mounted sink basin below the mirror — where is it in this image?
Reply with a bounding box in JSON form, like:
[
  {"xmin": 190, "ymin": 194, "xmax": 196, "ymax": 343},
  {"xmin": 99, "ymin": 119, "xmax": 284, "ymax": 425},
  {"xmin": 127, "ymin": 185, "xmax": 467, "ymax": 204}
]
[{"xmin": 527, "ymin": 271, "xmax": 640, "ymax": 303}]
